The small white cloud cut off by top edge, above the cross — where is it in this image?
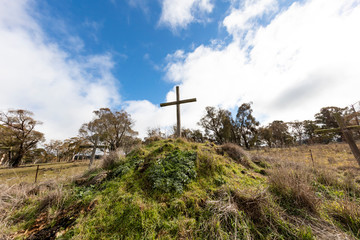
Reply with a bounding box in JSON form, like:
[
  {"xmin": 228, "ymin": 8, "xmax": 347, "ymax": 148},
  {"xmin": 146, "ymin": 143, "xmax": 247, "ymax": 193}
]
[{"xmin": 159, "ymin": 0, "xmax": 214, "ymax": 31}]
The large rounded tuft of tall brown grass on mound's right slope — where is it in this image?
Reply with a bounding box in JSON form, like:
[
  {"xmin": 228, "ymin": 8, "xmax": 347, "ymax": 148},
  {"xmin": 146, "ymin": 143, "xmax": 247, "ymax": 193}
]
[{"xmin": 268, "ymin": 164, "xmax": 319, "ymax": 213}]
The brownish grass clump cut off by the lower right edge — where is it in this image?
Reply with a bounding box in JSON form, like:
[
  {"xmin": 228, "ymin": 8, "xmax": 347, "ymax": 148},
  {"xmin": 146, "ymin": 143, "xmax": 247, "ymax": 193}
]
[{"xmin": 327, "ymin": 199, "xmax": 360, "ymax": 238}]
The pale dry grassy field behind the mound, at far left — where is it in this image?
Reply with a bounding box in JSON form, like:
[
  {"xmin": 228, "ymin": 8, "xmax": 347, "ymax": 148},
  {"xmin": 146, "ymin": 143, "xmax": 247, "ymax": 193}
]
[{"xmin": 0, "ymin": 161, "xmax": 89, "ymax": 186}]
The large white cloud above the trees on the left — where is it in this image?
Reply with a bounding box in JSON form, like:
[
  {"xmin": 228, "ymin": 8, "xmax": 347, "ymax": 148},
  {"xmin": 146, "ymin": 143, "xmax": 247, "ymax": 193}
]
[{"xmin": 0, "ymin": 0, "xmax": 120, "ymax": 139}]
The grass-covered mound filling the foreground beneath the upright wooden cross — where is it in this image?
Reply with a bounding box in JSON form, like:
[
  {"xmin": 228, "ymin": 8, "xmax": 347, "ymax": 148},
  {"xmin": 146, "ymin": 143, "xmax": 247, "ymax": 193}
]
[{"xmin": 0, "ymin": 139, "xmax": 360, "ymax": 239}]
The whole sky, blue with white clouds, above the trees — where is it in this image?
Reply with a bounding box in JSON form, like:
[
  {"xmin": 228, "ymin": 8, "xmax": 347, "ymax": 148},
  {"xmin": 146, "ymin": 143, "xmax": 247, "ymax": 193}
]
[{"xmin": 0, "ymin": 0, "xmax": 360, "ymax": 140}]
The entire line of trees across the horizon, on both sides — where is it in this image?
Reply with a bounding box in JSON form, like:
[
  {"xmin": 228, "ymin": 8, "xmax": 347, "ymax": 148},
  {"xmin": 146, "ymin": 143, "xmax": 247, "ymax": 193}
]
[{"xmin": 0, "ymin": 103, "xmax": 360, "ymax": 167}]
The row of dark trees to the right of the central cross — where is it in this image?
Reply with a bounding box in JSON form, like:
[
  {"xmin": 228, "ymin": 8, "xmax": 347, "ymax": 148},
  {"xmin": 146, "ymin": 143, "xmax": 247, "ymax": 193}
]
[{"xmin": 145, "ymin": 103, "xmax": 360, "ymax": 149}]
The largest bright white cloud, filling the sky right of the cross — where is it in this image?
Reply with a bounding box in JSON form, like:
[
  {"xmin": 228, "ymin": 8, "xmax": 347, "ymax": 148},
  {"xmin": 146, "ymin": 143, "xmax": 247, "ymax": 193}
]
[{"xmin": 127, "ymin": 0, "xmax": 360, "ymax": 135}]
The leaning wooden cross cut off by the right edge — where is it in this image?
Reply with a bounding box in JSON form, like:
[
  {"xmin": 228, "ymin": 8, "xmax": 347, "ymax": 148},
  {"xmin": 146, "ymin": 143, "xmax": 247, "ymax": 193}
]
[{"xmin": 315, "ymin": 113, "xmax": 360, "ymax": 165}]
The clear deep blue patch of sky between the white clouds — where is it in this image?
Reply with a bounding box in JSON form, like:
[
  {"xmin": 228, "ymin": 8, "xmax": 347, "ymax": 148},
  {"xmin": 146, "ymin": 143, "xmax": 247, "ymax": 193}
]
[{"xmin": 35, "ymin": 0, "xmax": 230, "ymax": 103}]
